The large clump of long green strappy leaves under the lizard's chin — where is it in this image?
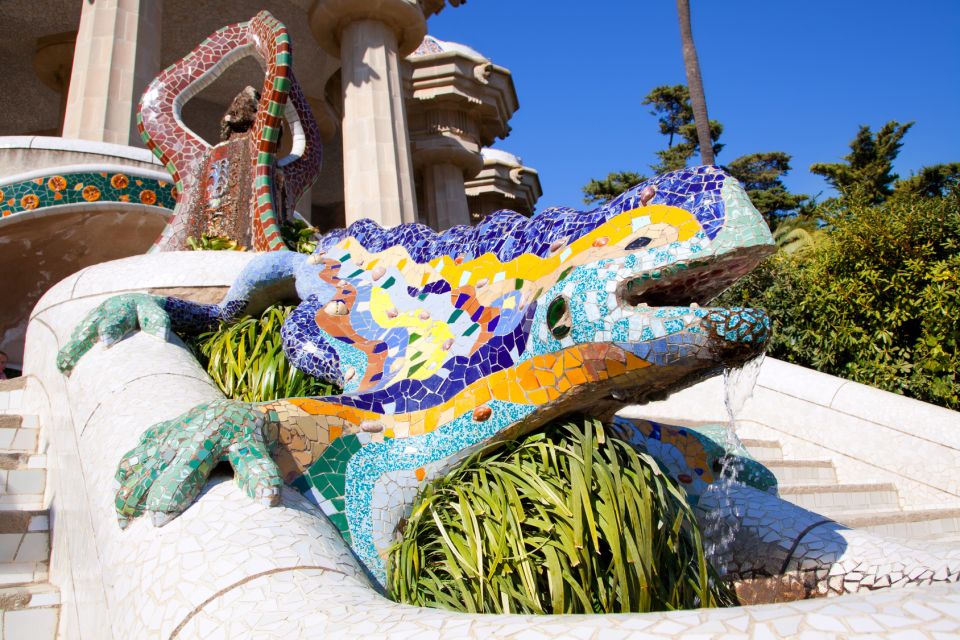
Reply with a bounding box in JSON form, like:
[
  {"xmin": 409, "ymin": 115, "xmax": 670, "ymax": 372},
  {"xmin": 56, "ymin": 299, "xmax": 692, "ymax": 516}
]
[{"xmin": 387, "ymin": 419, "xmax": 736, "ymax": 614}]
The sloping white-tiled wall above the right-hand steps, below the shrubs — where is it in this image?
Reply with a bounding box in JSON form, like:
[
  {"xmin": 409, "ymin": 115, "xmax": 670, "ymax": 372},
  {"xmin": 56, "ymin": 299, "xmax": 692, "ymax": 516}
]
[{"xmin": 621, "ymin": 358, "xmax": 960, "ymax": 508}]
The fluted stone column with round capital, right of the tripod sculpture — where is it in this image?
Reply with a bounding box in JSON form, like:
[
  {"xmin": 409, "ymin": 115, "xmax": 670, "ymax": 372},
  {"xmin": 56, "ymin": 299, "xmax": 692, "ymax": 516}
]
[{"xmin": 310, "ymin": 0, "xmax": 426, "ymax": 227}]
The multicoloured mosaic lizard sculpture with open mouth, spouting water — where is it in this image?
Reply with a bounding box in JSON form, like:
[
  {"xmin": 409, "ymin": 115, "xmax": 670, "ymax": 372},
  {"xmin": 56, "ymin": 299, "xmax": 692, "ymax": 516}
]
[{"xmin": 58, "ymin": 167, "xmax": 773, "ymax": 580}]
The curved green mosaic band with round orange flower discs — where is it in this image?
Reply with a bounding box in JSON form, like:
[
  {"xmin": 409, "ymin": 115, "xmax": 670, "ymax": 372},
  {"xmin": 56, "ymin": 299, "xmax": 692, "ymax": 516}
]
[{"xmin": 0, "ymin": 172, "xmax": 177, "ymax": 218}]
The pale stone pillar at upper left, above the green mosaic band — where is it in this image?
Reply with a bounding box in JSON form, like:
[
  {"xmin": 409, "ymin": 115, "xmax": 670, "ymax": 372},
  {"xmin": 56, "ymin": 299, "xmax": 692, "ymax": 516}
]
[{"xmin": 63, "ymin": 0, "xmax": 163, "ymax": 145}]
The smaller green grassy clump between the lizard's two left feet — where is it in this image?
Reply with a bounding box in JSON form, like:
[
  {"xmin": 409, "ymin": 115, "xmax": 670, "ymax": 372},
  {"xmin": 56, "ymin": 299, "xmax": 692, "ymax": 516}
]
[{"xmin": 191, "ymin": 305, "xmax": 340, "ymax": 402}]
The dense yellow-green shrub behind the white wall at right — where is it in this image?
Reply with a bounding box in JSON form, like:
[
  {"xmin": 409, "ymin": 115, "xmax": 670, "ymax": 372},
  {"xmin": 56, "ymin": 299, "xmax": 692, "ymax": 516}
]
[{"xmin": 717, "ymin": 192, "xmax": 960, "ymax": 409}]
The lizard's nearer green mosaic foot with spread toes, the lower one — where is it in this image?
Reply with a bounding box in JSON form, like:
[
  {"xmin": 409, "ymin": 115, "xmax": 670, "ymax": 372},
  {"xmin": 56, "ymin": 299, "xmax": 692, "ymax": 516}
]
[{"xmin": 115, "ymin": 400, "xmax": 283, "ymax": 526}]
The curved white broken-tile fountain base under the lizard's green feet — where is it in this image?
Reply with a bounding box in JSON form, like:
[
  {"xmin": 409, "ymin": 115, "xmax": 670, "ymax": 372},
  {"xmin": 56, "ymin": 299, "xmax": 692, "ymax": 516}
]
[{"xmin": 18, "ymin": 252, "xmax": 960, "ymax": 640}]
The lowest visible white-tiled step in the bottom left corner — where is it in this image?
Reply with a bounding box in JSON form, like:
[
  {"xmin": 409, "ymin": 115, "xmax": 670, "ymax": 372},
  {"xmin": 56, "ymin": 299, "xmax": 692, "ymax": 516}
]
[{"xmin": 0, "ymin": 583, "xmax": 60, "ymax": 640}]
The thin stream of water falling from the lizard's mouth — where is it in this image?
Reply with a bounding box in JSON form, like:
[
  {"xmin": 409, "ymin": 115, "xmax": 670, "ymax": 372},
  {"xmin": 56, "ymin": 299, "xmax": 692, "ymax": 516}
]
[{"xmin": 702, "ymin": 354, "xmax": 764, "ymax": 575}]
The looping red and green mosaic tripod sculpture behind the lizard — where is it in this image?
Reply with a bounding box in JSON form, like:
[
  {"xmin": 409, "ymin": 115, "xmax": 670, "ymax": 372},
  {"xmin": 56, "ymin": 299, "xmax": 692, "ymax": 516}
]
[{"xmin": 137, "ymin": 11, "xmax": 322, "ymax": 251}]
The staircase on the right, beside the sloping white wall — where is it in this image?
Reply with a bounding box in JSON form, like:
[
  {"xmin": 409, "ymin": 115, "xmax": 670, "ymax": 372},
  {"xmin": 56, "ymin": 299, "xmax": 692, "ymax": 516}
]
[{"xmin": 742, "ymin": 438, "xmax": 960, "ymax": 543}]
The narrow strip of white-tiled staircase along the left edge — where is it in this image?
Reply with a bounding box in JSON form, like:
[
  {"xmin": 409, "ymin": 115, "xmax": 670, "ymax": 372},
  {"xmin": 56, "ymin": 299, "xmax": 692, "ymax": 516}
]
[{"xmin": 0, "ymin": 378, "xmax": 60, "ymax": 640}]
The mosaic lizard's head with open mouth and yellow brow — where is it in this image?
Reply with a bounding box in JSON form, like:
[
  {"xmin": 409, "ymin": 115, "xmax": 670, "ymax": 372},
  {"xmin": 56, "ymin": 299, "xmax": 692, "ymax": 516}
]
[{"xmin": 512, "ymin": 168, "xmax": 773, "ymax": 420}]
